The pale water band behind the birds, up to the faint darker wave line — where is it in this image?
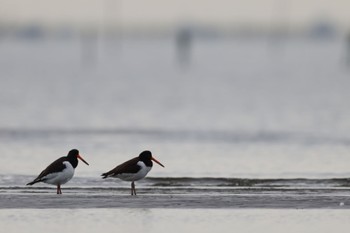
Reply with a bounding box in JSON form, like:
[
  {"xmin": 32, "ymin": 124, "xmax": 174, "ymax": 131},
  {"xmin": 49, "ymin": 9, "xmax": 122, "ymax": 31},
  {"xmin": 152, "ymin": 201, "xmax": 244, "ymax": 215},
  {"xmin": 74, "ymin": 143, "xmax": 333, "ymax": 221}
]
[{"xmin": 0, "ymin": 127, "xmax": 350, "ymax": 178}]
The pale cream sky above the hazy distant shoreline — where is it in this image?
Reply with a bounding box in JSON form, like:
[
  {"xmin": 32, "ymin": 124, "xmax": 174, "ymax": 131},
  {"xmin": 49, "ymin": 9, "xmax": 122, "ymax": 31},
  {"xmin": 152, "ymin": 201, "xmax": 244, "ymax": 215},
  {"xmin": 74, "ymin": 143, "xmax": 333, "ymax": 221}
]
[{"xmin": 0, "ymin": 0, "xmax": 350, "ymax": 30}]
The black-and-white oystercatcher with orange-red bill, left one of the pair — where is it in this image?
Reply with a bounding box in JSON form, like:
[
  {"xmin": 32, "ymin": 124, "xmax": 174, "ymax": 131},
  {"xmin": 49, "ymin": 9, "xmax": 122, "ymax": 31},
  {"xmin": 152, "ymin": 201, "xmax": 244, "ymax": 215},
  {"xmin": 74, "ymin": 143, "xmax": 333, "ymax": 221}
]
[{"xmin": 27, "ymin": 149, "xmax": 89, "ymax": 194}]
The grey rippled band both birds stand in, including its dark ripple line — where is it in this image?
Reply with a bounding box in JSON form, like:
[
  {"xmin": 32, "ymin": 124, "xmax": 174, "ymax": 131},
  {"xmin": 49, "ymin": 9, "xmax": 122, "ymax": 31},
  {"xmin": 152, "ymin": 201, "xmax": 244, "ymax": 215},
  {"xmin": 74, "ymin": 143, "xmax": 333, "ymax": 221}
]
[{"xmin": 0, "ymin": 176, "xmax": 350, "ymax": 209}]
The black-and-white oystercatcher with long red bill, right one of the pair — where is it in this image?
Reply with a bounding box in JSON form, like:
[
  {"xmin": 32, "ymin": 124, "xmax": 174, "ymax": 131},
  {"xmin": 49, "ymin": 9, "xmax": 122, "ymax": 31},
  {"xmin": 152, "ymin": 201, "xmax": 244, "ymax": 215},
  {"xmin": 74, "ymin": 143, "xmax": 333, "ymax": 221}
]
[{"xmin": 101, "ymin": 150, "xmax": 164, "ymax": 195}]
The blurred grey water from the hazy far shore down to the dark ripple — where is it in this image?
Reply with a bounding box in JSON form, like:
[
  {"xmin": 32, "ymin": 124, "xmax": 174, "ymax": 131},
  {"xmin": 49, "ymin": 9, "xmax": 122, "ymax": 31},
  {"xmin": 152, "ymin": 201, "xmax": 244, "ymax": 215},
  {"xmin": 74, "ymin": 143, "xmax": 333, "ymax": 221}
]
[{"xmin": 0, "ymin": 37, "xmax": 350, "ymax": 178}]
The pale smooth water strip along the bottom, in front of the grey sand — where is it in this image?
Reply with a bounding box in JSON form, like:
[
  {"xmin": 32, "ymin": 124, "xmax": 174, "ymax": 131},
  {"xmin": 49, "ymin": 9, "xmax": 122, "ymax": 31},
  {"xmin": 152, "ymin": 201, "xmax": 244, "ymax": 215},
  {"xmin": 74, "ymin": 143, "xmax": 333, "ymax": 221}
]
[{"xmin": 0, "ymin": 208, "xmax": 350, "ymax": 233}]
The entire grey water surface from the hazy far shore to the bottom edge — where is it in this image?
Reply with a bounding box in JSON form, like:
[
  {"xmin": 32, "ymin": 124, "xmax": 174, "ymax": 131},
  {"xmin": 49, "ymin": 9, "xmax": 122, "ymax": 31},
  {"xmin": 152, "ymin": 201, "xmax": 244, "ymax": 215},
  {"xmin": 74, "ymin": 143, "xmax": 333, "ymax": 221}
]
[{"xmin": 0, "ymin": 37, "xmax": 350, "ymax": 233}]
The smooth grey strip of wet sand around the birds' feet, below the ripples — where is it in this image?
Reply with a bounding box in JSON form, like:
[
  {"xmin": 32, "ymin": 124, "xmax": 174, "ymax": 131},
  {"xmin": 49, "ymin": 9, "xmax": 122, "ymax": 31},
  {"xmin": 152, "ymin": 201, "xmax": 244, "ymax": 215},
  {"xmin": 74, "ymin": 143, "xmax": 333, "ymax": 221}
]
[{"xmin": 0, "ymin": 187, "xmax": 350, "ymax": 209}]
